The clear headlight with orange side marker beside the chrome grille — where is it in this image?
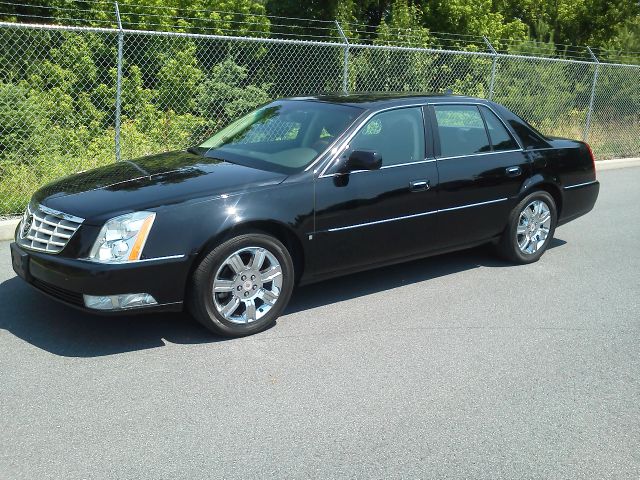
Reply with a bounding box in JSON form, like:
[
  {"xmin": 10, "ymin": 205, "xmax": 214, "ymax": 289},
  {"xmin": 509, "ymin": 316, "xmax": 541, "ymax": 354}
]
[{"xmin": 89, "ymin": 212, "xmax": 156, "ymax": 263}]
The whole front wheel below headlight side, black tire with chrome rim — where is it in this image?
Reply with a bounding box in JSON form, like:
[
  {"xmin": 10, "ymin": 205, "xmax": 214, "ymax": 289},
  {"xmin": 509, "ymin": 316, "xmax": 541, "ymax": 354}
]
[{"xmin": 187, "ymin": 233, "xmax": 294, "ymax": 337}]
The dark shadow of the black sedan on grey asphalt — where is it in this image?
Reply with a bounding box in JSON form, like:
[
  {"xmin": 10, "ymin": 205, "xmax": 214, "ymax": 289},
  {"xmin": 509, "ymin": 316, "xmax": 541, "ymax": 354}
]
[{"xmin": 0, "ymin": 239, "xmax": 566, "ymax": 357}]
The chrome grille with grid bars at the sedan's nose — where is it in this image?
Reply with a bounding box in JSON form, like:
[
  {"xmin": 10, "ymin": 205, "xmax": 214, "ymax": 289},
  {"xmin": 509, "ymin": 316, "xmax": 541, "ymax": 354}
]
[{"xmin": 17, "ymin": 205, "xmax": 84, "ymax": 253}]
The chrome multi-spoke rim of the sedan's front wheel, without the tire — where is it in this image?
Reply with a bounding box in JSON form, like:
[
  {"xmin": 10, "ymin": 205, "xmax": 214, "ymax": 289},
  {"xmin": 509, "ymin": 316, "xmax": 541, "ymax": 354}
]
[{"xmin": 213, "ymin": 247, "xmax": 282, "ymax": 324}]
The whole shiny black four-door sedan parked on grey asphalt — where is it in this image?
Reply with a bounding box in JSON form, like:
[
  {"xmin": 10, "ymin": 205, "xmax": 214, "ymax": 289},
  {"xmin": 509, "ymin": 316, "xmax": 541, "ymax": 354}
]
[{"xmin": 11, "ymin": 95, "xmax": 599, "ymax": 336}]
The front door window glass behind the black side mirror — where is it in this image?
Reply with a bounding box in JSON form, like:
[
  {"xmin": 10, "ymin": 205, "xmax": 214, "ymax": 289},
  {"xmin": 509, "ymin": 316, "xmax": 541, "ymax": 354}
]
[{"xmin": 349, "ymin": 107, "xmax": 425, "ymax": 166}]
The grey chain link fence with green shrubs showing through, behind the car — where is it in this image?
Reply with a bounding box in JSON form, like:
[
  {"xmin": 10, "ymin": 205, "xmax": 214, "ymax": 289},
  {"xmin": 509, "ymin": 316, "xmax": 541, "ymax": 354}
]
[{"xmin": 0, "ymin": 22, "xmax": 640, "ymax": 215}]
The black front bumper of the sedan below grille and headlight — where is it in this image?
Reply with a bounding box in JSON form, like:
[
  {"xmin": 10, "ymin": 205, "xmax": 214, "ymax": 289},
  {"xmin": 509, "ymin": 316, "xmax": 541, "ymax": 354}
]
[{"xmin": 10, "ymin": 243, "xmax": 191, "ymax": 314}]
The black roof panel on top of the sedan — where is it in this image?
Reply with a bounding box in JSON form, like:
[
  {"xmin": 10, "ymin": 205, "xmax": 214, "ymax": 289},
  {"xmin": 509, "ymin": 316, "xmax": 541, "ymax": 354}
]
[{"xmin": 283, "ymin": 92, "xmax": 489, "ymax": 110}]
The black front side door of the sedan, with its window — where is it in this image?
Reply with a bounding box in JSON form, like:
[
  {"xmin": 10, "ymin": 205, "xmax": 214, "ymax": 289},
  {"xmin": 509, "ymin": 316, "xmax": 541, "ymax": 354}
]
[{"xmin": 313, "ymin": 107, "xmax": 438, "ymax": 276}]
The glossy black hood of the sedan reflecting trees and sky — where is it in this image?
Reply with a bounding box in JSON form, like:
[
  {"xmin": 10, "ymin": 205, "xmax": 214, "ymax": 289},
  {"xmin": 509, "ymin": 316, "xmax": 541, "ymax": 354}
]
[{"xmin": 33, "ymin": 151, "xmax": 286, "ymax": 224}]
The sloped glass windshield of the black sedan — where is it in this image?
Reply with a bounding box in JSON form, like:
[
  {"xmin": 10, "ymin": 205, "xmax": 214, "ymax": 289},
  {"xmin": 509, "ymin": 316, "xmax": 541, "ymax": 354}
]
[{"xmin": 199, "ymin": 100, "xmax": 362, "ymax": 174}]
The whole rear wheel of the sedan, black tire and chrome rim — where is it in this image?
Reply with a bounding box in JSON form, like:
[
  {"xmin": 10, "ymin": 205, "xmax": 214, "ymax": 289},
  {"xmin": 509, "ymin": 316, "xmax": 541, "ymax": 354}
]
[{"xmin": 497, "ymin": 191, "xmax": 558, "ymax": 264}]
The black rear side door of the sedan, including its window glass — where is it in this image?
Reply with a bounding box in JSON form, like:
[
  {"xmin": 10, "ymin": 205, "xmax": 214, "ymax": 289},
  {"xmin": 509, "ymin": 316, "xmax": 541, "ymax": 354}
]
[{"xmin": 429, "ymin": 104, "xmax": 531, "ymax": 246}]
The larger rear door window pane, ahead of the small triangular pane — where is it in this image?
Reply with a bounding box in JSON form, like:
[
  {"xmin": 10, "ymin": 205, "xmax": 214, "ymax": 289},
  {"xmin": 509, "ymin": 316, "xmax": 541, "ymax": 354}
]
[{"xmin": 434, "ymin": 105, "xmax": 491, "ymax": 157}]
